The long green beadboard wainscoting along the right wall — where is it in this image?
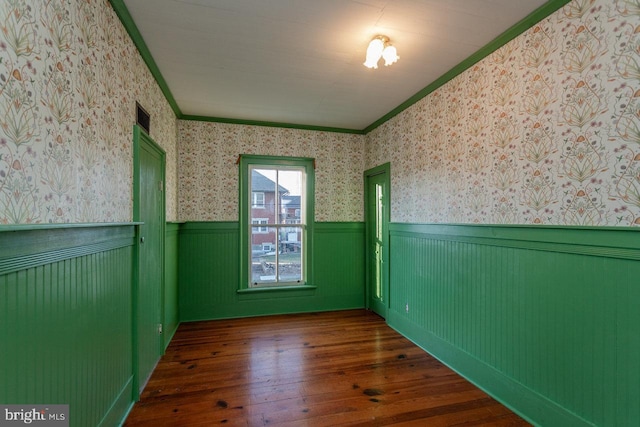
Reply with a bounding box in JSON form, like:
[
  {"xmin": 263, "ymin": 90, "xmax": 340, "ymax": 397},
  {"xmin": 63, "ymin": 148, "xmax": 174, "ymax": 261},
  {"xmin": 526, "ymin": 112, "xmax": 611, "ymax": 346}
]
[{"xmin": 387, "ymin": 224, "xmax": 640, "ymax": 427}]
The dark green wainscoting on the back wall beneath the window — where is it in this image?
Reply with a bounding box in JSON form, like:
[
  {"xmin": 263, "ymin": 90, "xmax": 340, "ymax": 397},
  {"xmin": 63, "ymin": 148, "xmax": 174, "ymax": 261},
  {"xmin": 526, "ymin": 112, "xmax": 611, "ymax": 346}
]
[{"xmin": 178, "ymin": 222, "xmax": 365, "ymax": 321}]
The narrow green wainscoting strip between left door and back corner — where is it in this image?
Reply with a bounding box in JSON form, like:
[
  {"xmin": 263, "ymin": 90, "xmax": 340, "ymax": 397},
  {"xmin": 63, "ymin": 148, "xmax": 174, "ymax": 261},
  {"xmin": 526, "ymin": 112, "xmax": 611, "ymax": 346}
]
[{"xmin": 162, "ymin": 222, "xmax": 180, "ymax": 349}]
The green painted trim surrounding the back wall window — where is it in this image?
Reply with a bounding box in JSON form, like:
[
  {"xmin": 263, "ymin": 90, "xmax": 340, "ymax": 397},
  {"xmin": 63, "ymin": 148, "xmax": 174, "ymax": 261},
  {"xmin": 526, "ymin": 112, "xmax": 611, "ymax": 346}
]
[{"xmin": 238, "ymin": 154, "xmax": 315, "ymax": 293}]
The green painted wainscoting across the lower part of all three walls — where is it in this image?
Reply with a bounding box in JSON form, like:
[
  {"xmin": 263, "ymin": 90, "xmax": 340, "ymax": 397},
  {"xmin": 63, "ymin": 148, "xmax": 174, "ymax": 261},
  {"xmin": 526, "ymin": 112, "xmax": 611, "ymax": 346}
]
[{"xmin": 0, "ymin": 222, "xmax": 640, "ymax": 426}]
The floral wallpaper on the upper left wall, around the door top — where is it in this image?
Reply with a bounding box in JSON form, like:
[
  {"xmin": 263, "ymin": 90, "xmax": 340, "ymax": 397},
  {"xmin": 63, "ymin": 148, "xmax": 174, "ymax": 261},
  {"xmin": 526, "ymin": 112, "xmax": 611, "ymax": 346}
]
[{"xmin": 0, "ymin": 0, "xmax": 177, "ymax": 224}]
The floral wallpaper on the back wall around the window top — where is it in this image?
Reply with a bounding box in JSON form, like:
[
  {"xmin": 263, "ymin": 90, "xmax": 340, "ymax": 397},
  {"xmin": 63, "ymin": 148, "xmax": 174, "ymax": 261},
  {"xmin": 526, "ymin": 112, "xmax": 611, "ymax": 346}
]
[{"xmin": 178, "ymin": 120, "xmax": 365, "ymax": 221}]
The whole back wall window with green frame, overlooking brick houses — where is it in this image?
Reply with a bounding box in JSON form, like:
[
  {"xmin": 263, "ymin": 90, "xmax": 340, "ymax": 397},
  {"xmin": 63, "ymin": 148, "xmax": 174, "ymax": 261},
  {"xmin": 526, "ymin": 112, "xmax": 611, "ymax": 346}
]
[{"xmin": 240, "ymin": 155, "xmax": 314, "ymax": 289}]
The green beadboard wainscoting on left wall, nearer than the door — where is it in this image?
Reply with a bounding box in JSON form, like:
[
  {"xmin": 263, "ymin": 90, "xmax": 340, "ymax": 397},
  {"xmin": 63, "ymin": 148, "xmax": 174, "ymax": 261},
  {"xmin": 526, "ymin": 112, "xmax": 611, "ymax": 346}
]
[{"xmin": 0, "ymin": 224, "xmax": 135, "ymax": 426}]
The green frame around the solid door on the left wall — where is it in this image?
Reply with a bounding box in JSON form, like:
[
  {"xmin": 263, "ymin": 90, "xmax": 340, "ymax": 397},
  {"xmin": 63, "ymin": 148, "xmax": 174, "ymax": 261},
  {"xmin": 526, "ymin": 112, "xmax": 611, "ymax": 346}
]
[{"xmin": 131, "ymin": 124, "xmax": 167, "ymax": 401}]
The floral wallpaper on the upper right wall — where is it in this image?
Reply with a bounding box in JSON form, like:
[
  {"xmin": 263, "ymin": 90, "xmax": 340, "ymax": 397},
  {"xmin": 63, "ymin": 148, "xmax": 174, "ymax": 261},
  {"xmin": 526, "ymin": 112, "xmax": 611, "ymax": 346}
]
[{"xmin": 366, "ymin": 0, "xmax": 640, "ymax": 226}]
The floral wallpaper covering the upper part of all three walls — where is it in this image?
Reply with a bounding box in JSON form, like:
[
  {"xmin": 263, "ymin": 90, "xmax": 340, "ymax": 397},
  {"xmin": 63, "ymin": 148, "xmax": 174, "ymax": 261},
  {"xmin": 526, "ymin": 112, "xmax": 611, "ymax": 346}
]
[{"xmin": 5, "ymin": 0, "xmax": 640, "ymax": 226}]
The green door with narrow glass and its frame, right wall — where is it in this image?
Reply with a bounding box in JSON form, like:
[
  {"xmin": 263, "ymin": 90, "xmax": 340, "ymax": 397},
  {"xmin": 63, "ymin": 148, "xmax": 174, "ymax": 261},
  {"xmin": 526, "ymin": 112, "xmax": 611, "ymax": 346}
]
[{"xmin": 364, "ymin": 163, "xmax": 391, "ymax": 318}]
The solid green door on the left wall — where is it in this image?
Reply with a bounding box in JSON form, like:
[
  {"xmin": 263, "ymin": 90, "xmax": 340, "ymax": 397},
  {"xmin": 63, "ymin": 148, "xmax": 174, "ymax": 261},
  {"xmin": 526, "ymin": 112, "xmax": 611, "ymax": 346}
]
[{"xmin": 134, "ymin": 127, "xmax": 165, "ymax": 391}]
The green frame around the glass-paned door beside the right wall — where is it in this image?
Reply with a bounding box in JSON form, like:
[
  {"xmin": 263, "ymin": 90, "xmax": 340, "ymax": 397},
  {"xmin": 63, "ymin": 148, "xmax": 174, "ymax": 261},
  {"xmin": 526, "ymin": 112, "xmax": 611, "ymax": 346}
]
[{"xmin": 364, "ymin": 162, "xmax": 391, "ymax": 318}]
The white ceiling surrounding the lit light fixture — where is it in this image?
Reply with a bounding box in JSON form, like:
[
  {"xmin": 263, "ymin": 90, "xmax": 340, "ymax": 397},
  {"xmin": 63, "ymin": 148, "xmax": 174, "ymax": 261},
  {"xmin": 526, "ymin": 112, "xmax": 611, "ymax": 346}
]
[{"xmin": 124, "ymin": 0, "xmax": 546, "ymax": 129}]
